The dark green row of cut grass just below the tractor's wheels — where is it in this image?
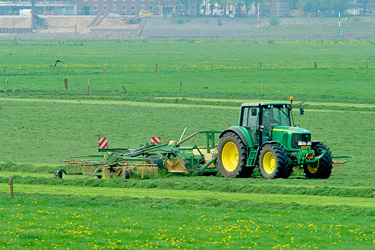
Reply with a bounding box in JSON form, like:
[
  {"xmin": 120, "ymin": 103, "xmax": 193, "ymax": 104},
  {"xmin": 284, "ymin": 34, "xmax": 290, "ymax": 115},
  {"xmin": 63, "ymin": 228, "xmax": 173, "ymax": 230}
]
[{"xmin": 0, "ymin": 173, "xmax": 374, "ymax": 198}]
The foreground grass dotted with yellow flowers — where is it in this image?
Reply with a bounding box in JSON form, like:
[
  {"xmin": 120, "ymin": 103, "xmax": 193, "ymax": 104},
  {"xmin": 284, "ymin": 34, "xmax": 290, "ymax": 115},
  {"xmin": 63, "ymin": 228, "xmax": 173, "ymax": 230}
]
[{"xmin": 0, "ymin": 194, "xmax": 375, "ymax": 249}]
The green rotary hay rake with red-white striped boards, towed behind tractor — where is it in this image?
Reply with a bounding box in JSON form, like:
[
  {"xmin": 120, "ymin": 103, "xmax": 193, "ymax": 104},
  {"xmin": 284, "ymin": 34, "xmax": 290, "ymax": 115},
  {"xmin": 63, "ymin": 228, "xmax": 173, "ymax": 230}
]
[{"xmin": 54, "ymin": 131, "xmax": 221, "ymax": 179}]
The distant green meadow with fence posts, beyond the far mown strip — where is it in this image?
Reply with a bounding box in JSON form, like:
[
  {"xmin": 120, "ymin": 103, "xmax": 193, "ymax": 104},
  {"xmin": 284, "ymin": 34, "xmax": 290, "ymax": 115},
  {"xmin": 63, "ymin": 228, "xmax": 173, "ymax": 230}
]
[{"xmin": 0, "ymin": 40, "xmax": 374, "ymax": 103}]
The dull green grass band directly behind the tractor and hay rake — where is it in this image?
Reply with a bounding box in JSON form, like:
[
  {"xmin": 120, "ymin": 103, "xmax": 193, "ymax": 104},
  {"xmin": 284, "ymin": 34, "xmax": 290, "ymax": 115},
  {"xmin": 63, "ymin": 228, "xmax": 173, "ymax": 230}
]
[{"xmin": 0, "ymin": 96, "xmax": 373, "ymax": 186}]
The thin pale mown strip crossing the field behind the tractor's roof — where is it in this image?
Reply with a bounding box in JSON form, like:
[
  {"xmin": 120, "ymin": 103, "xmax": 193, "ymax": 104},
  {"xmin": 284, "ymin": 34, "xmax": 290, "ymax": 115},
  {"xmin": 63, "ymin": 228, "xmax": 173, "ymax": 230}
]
[{"xmin": 1, "ymin": 91, "xmax": 375, "ymax": 112}]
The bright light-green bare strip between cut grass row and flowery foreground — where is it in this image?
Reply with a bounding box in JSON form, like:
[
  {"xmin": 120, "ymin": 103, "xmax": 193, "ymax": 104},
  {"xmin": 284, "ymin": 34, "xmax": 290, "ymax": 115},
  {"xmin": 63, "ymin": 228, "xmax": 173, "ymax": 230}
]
[{"xmin": 0, "ymin": 184, "xmax": 375, "ymax": 208}]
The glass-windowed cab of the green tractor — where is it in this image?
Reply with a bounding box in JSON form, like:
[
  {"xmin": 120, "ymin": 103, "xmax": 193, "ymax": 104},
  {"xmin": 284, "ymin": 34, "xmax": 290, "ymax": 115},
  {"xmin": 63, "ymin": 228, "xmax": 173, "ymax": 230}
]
[{"xmin": 239, "ymin": 103, "xmax": 291, "ymax": 147}]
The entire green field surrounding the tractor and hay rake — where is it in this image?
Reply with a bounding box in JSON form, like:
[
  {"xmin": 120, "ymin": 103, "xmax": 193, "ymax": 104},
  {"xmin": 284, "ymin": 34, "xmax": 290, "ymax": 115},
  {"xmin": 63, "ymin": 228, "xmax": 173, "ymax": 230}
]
[{"xmin": 0, "ymin": 39, "xmax": 375, "ymax": 249}]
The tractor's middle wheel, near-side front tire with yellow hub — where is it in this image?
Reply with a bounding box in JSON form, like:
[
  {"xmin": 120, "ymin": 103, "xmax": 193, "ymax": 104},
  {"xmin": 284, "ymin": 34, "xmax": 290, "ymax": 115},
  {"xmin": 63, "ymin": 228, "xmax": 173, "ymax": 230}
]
[{"xmin": 258, "ymin": 144, "xmax": 293, "ymax": 179}]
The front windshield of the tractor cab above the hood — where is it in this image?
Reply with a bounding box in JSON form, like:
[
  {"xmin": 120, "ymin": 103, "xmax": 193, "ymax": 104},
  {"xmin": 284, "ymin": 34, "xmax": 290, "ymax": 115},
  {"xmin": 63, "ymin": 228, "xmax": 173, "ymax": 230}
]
[{"xmin": 262, "ymin": 105, "xmax": 290, "ymax": 127}]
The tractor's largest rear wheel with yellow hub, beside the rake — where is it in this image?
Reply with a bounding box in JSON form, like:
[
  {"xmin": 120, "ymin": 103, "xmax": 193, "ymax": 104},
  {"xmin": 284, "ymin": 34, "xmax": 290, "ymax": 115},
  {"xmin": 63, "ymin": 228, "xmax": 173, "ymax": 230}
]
[{"xmin": 217, "ymin": 132, "xmax": 250, "ymax": 178}]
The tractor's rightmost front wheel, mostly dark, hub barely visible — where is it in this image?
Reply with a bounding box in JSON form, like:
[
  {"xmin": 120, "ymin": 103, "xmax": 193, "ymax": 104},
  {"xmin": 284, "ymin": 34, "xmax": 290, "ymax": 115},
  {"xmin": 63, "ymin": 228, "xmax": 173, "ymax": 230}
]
[{"xmin": 303, "ymin": 143, "xmax": 333, "ymax": 179}]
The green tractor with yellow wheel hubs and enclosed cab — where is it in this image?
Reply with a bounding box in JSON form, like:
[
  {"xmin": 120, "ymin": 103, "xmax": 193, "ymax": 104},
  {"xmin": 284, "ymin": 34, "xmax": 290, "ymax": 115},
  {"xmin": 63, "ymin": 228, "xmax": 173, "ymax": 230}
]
[{"xmin": 217, "ymin": 97, "xmax": 333, "ymax": 179}]
